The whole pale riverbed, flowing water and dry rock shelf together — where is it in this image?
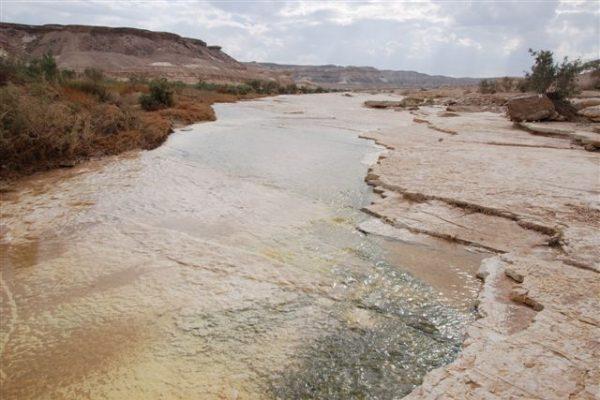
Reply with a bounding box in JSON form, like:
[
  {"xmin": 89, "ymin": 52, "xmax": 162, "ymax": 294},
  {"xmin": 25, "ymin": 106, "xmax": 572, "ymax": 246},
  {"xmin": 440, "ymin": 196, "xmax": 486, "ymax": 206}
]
[{"xmin": 0, "ymin": 93, "xmax": 600, "ymax": 399}]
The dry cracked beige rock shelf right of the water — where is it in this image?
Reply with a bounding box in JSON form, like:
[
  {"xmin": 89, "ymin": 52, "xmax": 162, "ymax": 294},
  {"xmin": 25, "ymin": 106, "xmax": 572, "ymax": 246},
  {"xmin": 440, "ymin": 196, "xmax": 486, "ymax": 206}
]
[{"xmin": 362, "ymin": 107, "xmax": 600, "ymax": 400}]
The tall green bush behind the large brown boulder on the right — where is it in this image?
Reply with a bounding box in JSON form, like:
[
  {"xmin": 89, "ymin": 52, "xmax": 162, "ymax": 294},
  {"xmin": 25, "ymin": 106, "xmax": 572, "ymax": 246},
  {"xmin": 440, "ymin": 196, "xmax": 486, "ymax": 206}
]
[{"xmin": 525, "ymin": 49, "xmax": 582, "ymax": 99}]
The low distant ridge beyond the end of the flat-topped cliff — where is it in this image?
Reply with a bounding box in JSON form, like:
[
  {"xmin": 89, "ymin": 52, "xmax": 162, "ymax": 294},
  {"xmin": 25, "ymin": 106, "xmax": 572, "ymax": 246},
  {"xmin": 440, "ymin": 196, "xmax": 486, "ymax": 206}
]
[{"xmin": 246, "ymin": 62, "xmax": 479, "ymax": 89}]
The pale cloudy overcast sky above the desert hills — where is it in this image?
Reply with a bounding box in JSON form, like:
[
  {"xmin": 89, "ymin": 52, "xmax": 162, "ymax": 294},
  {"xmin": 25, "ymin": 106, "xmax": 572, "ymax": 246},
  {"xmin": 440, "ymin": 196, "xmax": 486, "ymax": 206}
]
[{"xmin": 0, "ymin": 0, "xmax": 600, "ymax": 77}]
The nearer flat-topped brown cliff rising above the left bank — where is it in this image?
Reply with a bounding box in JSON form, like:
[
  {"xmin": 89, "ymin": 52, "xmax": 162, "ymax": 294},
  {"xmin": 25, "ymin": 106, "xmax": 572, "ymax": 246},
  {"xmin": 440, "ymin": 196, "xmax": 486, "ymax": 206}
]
[{"xmin": 0, "ymin": 23, "xmax": 268, "ymax": 82}]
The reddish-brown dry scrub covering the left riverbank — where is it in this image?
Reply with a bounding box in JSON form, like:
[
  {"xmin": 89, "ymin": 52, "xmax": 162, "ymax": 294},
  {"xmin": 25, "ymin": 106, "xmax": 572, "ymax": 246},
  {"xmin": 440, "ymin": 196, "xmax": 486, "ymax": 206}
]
[{"xmin": 0, "ymin": 82, "xmax": 256, "ymax": 178}]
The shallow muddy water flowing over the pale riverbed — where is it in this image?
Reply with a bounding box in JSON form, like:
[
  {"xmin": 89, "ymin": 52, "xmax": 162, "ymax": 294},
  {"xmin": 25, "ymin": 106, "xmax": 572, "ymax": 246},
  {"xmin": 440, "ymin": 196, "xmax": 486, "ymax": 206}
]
[{"xmin": 0, "ymin": 94, "xmax": 482, "ymax": 399}]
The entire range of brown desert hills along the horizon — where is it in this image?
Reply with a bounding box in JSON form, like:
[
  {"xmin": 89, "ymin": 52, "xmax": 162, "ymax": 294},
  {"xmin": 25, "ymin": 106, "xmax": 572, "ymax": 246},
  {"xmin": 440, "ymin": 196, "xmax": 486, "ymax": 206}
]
[{"xmin": 0, "ymin": 23, "xmax": 479, "ymax": 89}]
